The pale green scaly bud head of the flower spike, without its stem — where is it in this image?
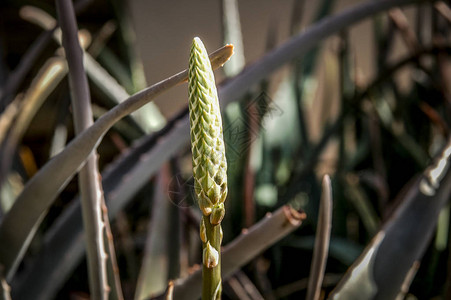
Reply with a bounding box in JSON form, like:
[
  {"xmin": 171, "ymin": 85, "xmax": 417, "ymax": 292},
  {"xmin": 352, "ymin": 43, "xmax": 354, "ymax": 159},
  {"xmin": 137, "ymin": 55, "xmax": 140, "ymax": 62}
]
[{"xmin": 188, "ymin": 38, "xmax": 227, "ymax": 216}]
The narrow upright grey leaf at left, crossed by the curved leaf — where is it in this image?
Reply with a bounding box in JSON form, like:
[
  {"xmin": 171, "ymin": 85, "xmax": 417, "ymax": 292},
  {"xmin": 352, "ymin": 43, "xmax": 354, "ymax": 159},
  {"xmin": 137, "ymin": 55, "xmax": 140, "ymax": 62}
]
[{"xmin": 56, "ymin": 0, "xmax": 117, "ymax": 299}]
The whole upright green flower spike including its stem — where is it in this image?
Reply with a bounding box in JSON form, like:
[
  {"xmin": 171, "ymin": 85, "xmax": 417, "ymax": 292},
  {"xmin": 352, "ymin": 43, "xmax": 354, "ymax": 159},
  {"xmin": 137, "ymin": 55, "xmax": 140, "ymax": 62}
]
[{"xmin": 188, "ymin": 37, "xmax": 227, "ymax": 300}]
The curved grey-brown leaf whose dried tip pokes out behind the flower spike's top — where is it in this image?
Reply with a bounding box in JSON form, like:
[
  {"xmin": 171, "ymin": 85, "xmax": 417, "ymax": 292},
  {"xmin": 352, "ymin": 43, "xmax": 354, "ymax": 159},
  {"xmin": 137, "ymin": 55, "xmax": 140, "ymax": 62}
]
[{"xmin": 0, "ymin": 46, "xmax": 232, "ymax": 281}]
